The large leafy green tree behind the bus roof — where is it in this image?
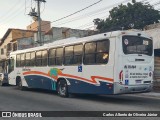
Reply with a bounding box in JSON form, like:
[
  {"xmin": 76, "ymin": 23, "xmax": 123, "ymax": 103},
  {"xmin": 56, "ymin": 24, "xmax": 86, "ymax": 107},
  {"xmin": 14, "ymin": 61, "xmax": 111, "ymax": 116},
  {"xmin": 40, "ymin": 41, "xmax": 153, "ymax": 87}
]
[{"xmin": 93, "ymin": 0, "xmax": 160, "ymax": 32}]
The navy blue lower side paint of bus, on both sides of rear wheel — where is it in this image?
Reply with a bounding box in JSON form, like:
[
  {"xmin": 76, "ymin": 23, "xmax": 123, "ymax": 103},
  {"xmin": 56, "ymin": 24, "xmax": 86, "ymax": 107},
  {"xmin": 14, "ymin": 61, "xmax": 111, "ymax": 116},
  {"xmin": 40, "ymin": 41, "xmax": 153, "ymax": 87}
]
[{"xmin": 25, "ymin": 75, "xmax": 113, "ymax": 94}]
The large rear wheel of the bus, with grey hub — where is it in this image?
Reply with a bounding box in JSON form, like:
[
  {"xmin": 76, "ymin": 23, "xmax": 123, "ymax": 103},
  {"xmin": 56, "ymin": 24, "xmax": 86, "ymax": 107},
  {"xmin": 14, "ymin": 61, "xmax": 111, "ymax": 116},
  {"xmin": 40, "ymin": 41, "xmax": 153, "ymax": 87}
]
[{"xmin": 57, "ymin": 79, "xmax": 69, "ymax": 98}]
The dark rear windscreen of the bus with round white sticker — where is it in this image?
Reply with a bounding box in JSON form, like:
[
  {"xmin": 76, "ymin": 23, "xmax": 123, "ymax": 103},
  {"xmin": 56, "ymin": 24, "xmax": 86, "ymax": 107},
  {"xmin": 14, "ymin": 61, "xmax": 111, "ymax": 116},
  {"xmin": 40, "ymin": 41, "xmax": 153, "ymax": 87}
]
[{"xmin": 122, "ymin": 35, "xmax": 153, "ymax": 56}]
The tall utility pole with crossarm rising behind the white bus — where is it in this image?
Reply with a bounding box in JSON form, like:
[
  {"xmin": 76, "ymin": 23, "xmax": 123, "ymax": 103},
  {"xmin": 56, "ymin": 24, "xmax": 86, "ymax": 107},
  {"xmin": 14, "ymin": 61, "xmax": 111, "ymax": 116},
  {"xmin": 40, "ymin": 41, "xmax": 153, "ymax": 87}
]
[{"xmin": 29, "ymin": 0, "xmax": 46, "ymax": 46}]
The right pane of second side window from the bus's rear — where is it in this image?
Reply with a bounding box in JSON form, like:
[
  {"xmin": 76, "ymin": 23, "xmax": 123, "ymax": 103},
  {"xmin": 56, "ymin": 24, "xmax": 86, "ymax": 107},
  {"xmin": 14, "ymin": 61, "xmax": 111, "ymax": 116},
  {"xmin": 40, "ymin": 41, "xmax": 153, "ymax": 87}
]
[{"xmin": 74, "ymin": 44, "xmax": 83, "ymax": 64}]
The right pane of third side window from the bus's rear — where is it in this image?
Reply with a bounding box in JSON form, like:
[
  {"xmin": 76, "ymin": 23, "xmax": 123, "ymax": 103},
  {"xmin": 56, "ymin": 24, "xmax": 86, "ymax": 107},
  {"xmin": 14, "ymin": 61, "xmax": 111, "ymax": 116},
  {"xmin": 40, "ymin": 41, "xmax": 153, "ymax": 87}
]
[{"xmin": 56, "ymin": 48, "xmax": 63, "ymax": 65}]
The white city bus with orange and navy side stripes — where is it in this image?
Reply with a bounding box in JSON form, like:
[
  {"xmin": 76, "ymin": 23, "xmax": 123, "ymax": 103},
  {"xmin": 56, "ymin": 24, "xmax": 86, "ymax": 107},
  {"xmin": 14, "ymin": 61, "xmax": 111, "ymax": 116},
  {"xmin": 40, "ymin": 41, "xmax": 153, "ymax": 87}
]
[{"xmin": 8, "ymin": 30, "xmax": 154, "ymax": 97}]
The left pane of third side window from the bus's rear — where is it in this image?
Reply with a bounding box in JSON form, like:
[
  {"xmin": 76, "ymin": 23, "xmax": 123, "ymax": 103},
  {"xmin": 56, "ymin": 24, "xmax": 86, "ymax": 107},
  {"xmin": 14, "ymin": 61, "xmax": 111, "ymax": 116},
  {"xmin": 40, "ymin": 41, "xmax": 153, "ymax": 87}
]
[{"xmin": 48, "ymin": 49, "xmax": 56, "ymax": 65}]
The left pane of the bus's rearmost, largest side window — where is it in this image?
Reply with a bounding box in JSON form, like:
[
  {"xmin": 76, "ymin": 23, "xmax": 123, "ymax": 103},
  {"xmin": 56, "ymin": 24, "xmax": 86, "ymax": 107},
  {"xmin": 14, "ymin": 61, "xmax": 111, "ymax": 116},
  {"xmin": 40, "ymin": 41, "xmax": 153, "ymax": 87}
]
[{"xmin": 84, "ymin": 42, "xmax": 96, "ymax": 64}]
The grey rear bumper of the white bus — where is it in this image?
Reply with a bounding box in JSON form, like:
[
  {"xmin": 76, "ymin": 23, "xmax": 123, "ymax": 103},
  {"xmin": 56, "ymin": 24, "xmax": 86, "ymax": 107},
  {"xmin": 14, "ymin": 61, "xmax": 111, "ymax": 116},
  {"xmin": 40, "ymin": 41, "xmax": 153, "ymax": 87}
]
[{"xmin": 114, "ymin": 83, "xmax": 153, "ymax": 94}]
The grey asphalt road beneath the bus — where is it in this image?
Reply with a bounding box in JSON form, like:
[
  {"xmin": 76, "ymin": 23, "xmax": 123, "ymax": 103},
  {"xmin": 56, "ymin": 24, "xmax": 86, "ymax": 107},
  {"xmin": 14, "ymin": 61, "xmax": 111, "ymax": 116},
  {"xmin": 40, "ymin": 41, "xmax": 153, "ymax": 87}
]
[{"xmin": 0, "ymin": 86, "xmax": 160, "ymax": 120}]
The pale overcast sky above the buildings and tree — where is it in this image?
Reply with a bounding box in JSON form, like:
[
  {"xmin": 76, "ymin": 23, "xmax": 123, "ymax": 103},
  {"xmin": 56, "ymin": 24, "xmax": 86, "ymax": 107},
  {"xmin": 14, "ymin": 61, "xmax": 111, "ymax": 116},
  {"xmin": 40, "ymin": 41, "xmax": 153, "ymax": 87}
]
[{"xmin": 0, "ymin": 0, "xmax": 160, "ymax": 38}]
